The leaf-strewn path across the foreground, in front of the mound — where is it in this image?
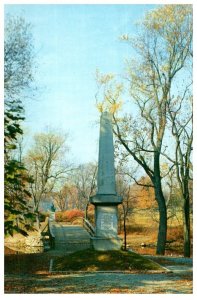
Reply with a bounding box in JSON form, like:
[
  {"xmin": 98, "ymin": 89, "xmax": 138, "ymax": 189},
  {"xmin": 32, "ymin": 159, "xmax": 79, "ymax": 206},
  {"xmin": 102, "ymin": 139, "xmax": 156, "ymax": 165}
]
[{"xmin": 5, "ymin": 256, "xmax": 192, "ymax": 294}]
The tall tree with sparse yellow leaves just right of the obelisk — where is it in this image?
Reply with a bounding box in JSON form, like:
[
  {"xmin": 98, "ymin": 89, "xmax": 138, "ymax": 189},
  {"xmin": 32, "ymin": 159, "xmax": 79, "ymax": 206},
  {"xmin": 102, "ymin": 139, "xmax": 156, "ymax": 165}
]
[{"xmin": 96, "ymin": 5, "xmax": 192, "ymax": 254}]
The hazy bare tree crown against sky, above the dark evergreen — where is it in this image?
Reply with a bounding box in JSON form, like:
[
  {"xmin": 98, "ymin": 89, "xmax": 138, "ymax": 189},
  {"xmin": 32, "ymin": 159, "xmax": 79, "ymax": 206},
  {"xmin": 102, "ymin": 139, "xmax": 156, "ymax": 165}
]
[{"xmin": 4, "ymin": 15, "xmax": 35, "ymax": 103}]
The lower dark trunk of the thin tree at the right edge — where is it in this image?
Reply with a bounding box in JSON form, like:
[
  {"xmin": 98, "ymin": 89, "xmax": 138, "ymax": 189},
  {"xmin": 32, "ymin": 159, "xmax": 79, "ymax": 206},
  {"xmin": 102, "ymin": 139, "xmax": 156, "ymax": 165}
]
[{"xmin": 183, "ymin": 195, "xmax": 190, "ymax": 257}]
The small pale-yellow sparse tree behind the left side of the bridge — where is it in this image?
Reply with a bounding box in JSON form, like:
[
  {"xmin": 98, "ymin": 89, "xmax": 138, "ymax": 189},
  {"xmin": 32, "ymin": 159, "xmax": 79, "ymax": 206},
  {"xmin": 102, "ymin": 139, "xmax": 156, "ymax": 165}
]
[{"xmin": 26, "ymin": 132, "xmax": 69, "ymax": 226}]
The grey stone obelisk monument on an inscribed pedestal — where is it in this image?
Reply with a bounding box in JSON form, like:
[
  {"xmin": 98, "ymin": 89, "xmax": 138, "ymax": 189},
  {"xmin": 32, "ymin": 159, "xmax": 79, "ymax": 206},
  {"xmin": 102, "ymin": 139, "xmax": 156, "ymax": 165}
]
[{"xmin": 90, "ymin": 111, "xmax": 122, "ymax": 251}]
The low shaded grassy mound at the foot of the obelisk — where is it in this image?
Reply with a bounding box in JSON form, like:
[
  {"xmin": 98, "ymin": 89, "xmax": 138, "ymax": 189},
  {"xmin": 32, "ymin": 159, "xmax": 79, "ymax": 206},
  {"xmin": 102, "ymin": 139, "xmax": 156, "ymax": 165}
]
[{"xmin": 53, "ymin": 249, "xmax": 165, "ymax": 272}]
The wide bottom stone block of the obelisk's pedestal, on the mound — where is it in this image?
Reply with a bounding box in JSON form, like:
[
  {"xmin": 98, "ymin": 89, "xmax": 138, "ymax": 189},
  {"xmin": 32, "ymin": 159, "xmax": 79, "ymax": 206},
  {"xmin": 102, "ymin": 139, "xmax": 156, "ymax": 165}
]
[{"xmin": 91, "ymin": 237, "xmax": 122, "ymax": 251}]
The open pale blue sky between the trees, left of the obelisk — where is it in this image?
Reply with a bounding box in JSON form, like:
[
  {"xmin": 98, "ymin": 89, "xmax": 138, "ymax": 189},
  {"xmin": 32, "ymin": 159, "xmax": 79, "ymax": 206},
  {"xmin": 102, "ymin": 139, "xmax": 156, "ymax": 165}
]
[{"xmin": 5, "ymin": 4, "xmax": 155, "ymax": 163}]
